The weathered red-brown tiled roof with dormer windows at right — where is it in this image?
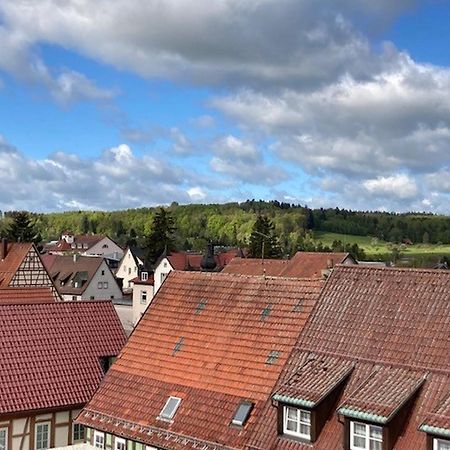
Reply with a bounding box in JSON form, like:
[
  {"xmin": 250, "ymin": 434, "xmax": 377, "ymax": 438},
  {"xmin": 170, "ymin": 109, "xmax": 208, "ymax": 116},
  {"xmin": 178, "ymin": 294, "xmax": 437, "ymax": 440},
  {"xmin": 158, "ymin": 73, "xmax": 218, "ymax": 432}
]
[{"xmin": 250, "ymin": 265, "xmax": 450, "ymax": 450}]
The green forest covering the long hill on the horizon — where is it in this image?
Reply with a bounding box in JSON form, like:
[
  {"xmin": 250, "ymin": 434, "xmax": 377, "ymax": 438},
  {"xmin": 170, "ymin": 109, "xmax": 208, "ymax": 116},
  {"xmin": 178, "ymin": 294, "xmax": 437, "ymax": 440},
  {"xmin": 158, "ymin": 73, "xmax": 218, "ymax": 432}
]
[{"xmin": 0, "ymin": 200, "xmax": 450, "ymax": 259}]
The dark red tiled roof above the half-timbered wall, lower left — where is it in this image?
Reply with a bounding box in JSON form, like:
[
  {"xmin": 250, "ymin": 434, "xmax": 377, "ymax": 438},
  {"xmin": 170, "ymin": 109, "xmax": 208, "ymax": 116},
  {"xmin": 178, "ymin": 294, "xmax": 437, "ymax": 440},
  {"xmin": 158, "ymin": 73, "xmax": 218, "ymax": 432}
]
[{"xmin": 0, "ymin": 301, "xmax": 126, "ymax": 415}]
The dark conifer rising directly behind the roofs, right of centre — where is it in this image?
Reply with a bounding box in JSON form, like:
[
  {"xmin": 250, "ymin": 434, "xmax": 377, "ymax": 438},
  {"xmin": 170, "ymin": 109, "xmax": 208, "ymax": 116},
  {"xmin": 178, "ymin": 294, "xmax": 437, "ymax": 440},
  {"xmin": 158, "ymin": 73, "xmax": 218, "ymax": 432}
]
[{"xmin": 249, "ymin": 216, "xmax": 281, "ymax": 258}]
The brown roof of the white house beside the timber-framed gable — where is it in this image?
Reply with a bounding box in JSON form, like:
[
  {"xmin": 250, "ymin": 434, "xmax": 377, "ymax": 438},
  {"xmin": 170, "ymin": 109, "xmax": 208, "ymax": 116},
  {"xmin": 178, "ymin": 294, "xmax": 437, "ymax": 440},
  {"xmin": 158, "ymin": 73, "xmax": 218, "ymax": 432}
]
[{"xmin": 42, "ymin": 255, "xmax": 103, "ymax": 295}]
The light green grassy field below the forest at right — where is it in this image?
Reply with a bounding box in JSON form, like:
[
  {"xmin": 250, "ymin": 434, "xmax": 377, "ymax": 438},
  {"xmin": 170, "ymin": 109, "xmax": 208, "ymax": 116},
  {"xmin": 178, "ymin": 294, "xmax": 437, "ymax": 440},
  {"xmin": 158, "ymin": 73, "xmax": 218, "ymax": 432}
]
[{"xmin": 314, "ymin": 231, "xmax": 450, "ymax": 260}]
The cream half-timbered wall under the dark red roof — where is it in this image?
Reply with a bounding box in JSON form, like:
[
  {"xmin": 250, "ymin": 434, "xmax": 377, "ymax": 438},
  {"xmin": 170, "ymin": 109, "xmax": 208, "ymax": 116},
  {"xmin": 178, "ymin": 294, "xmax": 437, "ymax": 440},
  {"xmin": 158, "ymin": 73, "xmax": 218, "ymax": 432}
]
[{"xmin": 0, "ymin": 409, "xmax": 82, "ymax": 450}]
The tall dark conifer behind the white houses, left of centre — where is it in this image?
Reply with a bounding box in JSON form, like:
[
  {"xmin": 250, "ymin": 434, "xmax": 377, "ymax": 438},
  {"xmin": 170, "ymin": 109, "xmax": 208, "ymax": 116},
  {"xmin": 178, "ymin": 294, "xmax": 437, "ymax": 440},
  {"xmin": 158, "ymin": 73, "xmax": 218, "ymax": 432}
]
[{"xmin": 145, "ymin": 208, "xmax": 175, "ymax": 265}]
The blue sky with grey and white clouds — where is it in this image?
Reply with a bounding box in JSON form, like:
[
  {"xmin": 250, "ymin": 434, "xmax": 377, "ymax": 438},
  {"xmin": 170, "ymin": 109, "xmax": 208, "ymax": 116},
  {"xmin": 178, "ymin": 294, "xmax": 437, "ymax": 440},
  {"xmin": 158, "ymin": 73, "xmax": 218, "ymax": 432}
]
[{"xmin": 0, "ymin": 0, "xmax": 450, "ymax": 214}]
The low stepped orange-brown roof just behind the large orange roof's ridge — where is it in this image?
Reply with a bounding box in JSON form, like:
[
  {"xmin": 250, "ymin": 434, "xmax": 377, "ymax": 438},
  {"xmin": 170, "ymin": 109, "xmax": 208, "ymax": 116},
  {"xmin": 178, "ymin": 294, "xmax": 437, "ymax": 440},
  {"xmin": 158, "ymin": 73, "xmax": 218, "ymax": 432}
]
[{"xmin": 224, "ymin": 252, "xmax": 355, "ymax": 278}]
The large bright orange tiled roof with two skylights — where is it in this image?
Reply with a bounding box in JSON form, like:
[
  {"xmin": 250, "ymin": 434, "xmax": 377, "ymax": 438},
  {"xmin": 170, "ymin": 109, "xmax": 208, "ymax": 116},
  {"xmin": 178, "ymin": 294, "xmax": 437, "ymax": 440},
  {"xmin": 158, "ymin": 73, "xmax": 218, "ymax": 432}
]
[{"xmin": 78, "ymin": 271, "xmax": 322, "ymax": 449}]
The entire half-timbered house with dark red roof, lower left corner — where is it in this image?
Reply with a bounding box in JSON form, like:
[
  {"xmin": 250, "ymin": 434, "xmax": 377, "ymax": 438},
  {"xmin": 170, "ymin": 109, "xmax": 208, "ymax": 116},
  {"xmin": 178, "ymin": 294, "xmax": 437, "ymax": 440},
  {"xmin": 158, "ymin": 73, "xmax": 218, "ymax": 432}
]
[{"xmin": 0, "ymin": 301, "xmax": 126, "ymax": 450}]
